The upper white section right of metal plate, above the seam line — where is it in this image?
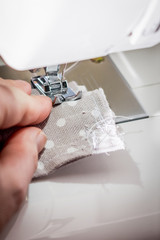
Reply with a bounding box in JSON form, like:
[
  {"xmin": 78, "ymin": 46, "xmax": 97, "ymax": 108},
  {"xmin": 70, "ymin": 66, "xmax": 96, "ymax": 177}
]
[{"xmin": 110, "ymin": 44, "xmax": 160, "ymax": 88}]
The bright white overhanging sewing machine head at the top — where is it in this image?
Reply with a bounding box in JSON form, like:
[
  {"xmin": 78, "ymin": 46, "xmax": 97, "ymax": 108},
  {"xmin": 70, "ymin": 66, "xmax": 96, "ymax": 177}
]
[{"xmin": 0, "ymin": 0, "xmax": 160, "ymax": 70}]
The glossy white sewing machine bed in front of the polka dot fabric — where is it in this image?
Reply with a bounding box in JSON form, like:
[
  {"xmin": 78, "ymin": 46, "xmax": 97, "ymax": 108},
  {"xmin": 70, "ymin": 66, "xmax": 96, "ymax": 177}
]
[{"xmin": 1, "ymin": 117, "xmax": 160, "ymax": 240}]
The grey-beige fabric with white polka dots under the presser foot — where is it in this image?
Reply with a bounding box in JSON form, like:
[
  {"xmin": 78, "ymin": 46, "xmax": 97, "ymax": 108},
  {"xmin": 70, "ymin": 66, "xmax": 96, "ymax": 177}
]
[{"xmin": 33, "ymin": 83, "xmax": 123, "ymax": 177}]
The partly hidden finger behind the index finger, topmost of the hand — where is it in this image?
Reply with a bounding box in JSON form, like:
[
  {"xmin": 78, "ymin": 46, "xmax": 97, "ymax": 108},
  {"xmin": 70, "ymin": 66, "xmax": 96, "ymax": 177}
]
[{"xmin": 0, "ymin": 78, "xmax": 31, "ymax": 95}]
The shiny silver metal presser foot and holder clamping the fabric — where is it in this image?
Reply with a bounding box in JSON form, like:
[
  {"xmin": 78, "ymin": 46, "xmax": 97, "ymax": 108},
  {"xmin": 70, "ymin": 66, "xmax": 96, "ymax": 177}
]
[{"xmin": 31, "ymin": 65, "xmax": 82, "ymax": 105}]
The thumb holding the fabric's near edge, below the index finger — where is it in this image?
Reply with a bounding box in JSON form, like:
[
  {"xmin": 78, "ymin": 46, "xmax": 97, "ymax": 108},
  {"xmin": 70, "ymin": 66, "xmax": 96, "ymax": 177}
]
[{"xmin": 0, "ymin": 127, "xmax": 46, "ymax": 230}]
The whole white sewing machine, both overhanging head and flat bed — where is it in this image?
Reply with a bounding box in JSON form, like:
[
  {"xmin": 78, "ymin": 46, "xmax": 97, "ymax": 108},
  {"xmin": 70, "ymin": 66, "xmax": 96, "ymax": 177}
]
[{"xmin": 0, "ymin": 0, "xmax": 160, "ymax": 240}]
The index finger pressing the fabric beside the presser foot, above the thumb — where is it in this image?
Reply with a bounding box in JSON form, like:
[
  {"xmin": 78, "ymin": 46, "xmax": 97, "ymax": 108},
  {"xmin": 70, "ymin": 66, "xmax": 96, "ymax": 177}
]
[{"xmin": 0, "ymin": 85, "xmax": 52, "ymax": 129}]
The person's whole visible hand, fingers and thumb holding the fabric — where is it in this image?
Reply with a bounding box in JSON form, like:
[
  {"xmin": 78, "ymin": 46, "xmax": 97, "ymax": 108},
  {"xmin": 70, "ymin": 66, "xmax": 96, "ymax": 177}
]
[{"xmin": 0, "ymin": 78, "xmax": 52, "ymax": 230}]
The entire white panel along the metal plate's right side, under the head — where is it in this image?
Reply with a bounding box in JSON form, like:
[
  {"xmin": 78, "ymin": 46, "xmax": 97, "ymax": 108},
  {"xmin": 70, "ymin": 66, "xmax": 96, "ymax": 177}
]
[{"xmin": 110, "ymin": 44, "xmax": 160, "ymax": 116}]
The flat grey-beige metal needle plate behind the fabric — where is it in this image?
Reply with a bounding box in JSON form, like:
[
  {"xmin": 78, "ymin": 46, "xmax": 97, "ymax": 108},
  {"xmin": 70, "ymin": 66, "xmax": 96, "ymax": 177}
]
[{"xmin": 65, "ymin": 57, "xmax": 148, "ymax": 123}]
